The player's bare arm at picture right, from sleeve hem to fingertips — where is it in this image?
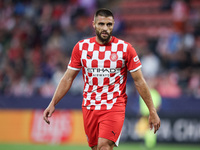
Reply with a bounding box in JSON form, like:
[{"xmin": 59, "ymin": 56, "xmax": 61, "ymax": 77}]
[{"xmin": 131, "ymin": 69, "xmax": 160, "ymax": 133}]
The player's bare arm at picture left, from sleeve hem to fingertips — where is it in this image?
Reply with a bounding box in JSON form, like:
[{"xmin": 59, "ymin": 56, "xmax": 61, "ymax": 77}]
[{"xmin": 43, "ymin": 69, "xmax": 79, "ymax": 124}]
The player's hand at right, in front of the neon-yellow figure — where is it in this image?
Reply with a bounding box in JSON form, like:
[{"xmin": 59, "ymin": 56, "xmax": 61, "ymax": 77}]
[{"xmin": 149, "ymin": 112, "xmax": 160, "ymax": 134}]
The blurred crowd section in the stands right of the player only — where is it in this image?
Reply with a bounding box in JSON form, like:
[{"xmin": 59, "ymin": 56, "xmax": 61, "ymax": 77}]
[{"xmin": 134, "ymin": 0, "xmax": 200, "ymax": 98}]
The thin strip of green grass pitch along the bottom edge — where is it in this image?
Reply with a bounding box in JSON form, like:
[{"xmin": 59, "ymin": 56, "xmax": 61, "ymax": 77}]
[{"xmin": 0, "ymin": 143, "xmax": 200, "ymax": 150}]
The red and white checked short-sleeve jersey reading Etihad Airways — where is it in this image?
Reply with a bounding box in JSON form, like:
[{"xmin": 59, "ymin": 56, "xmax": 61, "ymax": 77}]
[{"xmin": 68, "ymin": 37, "xmax": 141, "ymax": 110}]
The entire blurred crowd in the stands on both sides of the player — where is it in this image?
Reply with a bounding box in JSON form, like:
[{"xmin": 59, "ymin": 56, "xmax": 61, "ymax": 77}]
[{"xmin": 0, "ymin": 0, "xmax": 200, "ymax": 98}]
